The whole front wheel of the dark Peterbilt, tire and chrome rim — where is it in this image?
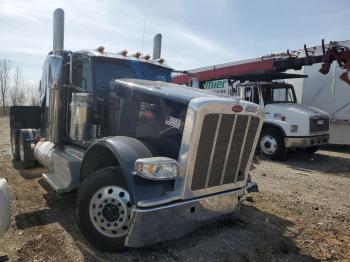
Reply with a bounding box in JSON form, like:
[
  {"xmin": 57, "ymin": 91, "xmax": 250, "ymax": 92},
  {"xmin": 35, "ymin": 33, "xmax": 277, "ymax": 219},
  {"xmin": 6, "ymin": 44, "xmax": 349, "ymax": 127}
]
[{"xmin": 75, "ymin": 166, "xmax": 132, "ymax": 251}]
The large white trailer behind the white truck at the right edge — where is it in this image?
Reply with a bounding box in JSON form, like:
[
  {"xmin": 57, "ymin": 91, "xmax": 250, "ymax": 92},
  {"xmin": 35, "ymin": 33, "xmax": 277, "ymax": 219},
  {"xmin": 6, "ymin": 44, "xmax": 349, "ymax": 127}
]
[{"xmin": 286, "ymin": 40, "xmax": 350, "ymax": 145}]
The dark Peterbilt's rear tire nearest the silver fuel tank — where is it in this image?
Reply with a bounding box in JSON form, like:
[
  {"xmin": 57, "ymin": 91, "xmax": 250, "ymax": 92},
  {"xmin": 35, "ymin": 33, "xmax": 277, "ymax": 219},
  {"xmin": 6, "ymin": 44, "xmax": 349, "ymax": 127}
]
[{"xmin": 18, "ymin": 129, "xmax": 37, "ymax": 168}]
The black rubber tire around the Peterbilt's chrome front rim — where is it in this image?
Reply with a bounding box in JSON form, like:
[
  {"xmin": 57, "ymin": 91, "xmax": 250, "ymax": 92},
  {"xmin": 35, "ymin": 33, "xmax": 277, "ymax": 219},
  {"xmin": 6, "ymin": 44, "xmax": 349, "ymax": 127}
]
[{"xmin": 75, "ymin": 166, "xmax": 131, "ymax": 251}]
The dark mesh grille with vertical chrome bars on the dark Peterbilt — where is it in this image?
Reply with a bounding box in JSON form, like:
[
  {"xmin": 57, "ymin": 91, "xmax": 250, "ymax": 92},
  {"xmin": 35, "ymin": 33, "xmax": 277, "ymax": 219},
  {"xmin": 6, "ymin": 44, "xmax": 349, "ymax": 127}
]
[{"xmin": 191, "ymin": 114, "xmax": 260, "ymax": 191}]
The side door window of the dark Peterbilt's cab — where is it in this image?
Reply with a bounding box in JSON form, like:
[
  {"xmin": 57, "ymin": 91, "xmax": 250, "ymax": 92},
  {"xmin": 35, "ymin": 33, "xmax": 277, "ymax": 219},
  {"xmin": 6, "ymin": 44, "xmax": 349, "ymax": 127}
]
[{"xmin": 73, "ymin": 54, "xmax": 91, "ymax": 91}]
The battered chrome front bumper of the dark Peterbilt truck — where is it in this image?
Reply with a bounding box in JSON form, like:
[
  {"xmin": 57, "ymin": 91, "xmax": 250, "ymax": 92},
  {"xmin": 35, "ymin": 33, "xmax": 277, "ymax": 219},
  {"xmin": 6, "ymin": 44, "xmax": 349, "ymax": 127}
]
[{"xmin": 125, "ymin": 189, "xmax": 245, "ymax": 247}]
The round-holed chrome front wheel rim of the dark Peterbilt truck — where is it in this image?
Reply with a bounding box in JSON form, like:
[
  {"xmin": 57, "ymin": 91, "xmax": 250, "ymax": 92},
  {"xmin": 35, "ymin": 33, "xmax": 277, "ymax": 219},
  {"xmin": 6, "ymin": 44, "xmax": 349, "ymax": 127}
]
[{"xmin": 89, "ymin": 186, "xmax": 131, "ymax": 238}]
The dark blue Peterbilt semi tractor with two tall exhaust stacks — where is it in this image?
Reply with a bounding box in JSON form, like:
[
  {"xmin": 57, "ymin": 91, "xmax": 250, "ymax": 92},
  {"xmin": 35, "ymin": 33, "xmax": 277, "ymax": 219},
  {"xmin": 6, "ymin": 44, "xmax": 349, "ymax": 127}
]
[{"xmin": 10, "ymin": 9, "xmax": 263, "ymax": 250}]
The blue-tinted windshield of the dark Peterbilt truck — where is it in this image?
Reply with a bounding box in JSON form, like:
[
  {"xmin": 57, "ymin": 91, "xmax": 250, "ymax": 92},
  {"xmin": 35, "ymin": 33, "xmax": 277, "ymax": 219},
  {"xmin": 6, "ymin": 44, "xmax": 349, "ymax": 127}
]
[{"xmin": 94, "ymin": 58, "xmax": 172, "ymax": 89}]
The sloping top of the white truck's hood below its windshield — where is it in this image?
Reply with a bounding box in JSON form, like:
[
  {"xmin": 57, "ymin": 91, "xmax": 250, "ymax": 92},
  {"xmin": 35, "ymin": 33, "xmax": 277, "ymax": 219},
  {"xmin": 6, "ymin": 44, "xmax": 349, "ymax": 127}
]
[{"xmin": 265, "ymin": 103, "xmax": 328, "ymax": 116}]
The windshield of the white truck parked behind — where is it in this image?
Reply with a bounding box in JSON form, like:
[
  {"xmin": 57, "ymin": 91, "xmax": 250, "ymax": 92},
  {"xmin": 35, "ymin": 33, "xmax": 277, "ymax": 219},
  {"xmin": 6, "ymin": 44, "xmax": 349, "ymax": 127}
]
[{"xmin": 261, "ymin": 85, "xmax": 297, "ymax": 105}]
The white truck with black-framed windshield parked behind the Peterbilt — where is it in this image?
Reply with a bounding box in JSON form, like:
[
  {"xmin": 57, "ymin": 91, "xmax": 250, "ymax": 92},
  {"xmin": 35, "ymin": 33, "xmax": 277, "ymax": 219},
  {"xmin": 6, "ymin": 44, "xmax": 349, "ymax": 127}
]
[{"xmin": 204, "ymin": 79, "xmax": 329, "ymax": 159}]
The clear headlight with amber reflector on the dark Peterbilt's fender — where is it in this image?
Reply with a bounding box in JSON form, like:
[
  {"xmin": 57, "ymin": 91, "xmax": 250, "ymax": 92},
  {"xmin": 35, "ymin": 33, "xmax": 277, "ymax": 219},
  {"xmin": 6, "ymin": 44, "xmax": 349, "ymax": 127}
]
[{"xmin": 135, "ymin": 157, "xmax": 179, "ymax": 180}]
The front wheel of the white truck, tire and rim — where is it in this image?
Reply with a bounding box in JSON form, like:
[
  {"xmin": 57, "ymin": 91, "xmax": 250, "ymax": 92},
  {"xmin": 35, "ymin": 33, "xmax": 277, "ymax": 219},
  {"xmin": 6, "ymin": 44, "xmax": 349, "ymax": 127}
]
[{"xmin": 258, "ymin": 128, "xmax": 286, "ymax": 160}]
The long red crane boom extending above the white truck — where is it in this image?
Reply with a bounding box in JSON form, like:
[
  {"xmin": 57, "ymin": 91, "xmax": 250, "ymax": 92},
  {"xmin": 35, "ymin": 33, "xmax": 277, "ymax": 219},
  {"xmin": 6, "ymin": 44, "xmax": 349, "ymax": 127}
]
[{"xmin": 173, "ymin": 40, "xmax": 350, "ymax": 85}]
